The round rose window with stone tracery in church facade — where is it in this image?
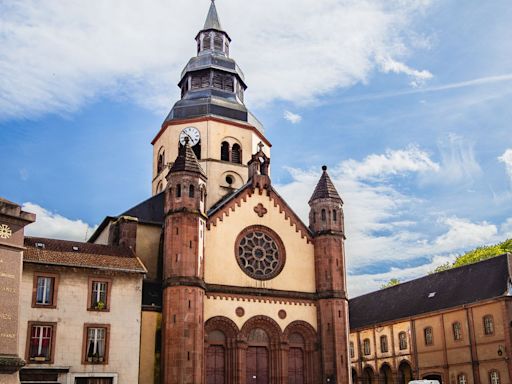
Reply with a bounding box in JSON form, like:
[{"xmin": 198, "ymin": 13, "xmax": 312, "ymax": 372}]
[{"xmin": 235, "ymin": 225, "xmax": 285, "ymax": 280}]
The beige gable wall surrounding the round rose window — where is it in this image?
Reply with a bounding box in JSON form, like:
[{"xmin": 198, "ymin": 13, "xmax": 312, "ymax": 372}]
[{"xmin": 205, "ymin": 193, "xmax": 315, "ymax": 292}]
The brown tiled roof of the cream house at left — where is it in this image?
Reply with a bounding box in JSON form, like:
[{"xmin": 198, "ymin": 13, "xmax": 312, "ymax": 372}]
[{"xmin": 23, "ymin": 237, "xmax": 147, "ymax": 273}]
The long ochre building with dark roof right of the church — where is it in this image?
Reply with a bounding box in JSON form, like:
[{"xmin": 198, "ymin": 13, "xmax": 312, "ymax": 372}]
[{"xmin": 350, "ymin": 254, "xmax": 512, "ymax": 384}]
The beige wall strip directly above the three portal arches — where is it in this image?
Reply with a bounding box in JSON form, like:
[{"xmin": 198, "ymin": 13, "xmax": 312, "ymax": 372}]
[{"xmin": 204, "ymin": 295, "xmax": 317, "ymax": 331}]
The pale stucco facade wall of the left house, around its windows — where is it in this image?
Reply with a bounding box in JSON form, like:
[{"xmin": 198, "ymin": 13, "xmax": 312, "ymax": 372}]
[{"xmin": 19, "ymin": 263, "xmax": 142, "ymax": 384}]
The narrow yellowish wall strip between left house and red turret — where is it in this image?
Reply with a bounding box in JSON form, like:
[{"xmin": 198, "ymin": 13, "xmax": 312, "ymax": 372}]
[{"xmin": 139, "ymin": 311, "xmax": 162, "ymax": 384}]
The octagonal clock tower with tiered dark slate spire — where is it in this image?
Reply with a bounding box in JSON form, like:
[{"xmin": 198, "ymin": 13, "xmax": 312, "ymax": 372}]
[{"xmin": 152, "ymin": 1, "xmax": 271, "ymax": 209}]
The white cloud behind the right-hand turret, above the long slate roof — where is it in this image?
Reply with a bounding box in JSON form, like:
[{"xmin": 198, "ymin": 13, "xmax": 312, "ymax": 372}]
[{"xmin": 278, "ymin": 146, "xmax": 512, "ymax": 296}]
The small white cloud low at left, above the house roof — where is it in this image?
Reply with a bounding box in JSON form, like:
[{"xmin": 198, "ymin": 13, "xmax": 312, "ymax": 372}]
[{"xmin": 23, "ymin": 203, "xmax": 97, "ymax": 241}]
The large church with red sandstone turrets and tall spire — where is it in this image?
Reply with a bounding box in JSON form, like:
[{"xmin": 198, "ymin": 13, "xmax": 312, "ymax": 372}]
[{"xmin": 90, "ymin": 1, "xmax": 350, "ymax": 384}]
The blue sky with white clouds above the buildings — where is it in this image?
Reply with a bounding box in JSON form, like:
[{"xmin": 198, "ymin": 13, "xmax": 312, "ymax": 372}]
[{"xmin": 0, "ymin": 0, "xmax": 512, "ymax": 295}]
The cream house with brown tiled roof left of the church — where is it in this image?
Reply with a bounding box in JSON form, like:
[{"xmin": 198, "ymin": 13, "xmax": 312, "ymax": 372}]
[{"xmin": 19, "ymin": 237, "xmax": 146, "ymax": 384}]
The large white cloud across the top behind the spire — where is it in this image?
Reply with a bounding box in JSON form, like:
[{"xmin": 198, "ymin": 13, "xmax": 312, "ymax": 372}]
[{"xmin": 0, "ymin": 0, "xmax": 431, "ymax": 119}]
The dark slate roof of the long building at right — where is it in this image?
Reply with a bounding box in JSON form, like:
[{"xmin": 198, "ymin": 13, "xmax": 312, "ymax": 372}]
[{"xmin": 349, "ymin": 254, "xmax": 512, "ymax": 329}]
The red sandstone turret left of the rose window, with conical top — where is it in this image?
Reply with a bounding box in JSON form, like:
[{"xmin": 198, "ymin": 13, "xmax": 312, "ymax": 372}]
[{"xmin": 161, "ymin": 139, "xmax": 206, "ymax": 384}]
